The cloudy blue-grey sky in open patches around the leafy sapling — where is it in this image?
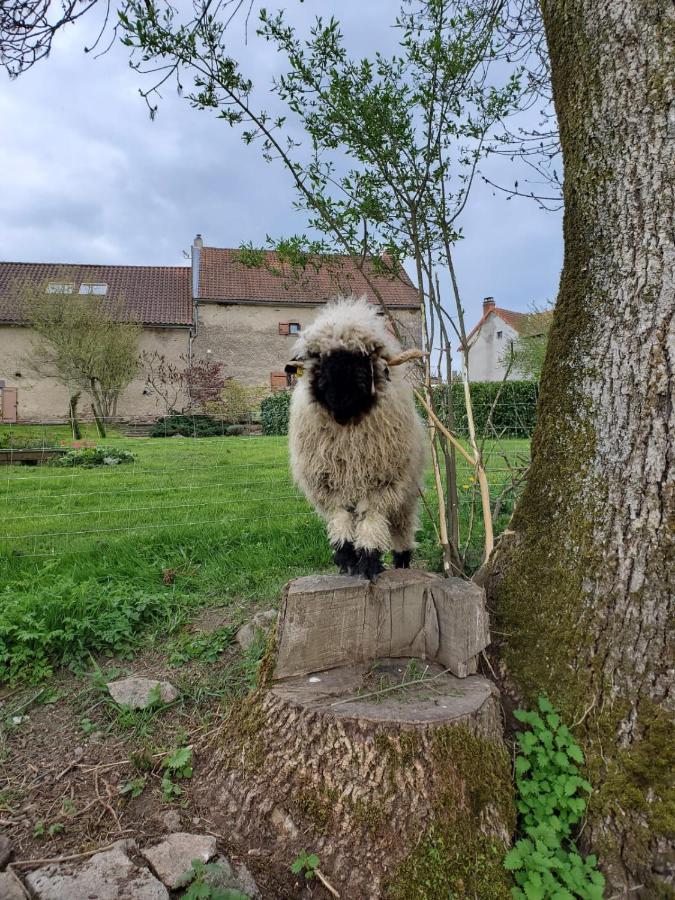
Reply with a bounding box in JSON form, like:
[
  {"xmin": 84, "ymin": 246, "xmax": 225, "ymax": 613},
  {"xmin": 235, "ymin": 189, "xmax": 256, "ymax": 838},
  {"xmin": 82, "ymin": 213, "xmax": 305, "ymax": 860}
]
[{"xmin": 0, "ymin": 0, "xmax": 562, "ymax": 325}]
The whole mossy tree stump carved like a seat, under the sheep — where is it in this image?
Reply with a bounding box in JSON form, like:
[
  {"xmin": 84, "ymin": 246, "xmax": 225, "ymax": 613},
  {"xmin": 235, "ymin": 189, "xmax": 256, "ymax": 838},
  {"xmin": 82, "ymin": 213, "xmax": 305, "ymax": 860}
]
[{"xmin": 199, "ymin": 571, "xmax": 513, "ymax": 900}]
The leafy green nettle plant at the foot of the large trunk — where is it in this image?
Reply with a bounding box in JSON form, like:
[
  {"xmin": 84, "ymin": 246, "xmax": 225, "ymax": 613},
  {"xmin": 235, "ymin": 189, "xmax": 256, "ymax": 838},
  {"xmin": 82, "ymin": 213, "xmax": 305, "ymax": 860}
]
[{"xmin": 504, "ymin": 697, "xmax": 605, "ymax": 900}]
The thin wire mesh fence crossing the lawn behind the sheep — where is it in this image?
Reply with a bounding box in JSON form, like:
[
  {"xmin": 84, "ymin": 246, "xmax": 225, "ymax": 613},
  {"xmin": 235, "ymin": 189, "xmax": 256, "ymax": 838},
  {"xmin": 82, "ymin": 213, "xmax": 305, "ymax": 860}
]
[{"xmin": 0, "ymin": 384, "xmax": 532, "ymax": 569}]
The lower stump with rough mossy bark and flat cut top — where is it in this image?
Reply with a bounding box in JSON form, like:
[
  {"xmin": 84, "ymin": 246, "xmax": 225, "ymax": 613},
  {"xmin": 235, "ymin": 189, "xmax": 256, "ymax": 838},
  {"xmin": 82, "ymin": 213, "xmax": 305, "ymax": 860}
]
[{"xmin": 199, "ymin": 659, "xmax": 514, "ymax": 900}]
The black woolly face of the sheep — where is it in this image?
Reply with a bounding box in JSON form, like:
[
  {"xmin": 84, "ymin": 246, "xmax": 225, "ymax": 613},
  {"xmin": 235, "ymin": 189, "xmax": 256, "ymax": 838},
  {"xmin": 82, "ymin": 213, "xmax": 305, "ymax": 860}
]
[{"xmin": 311, "ymin": 350, "xmax": 379, "ymax": 425}]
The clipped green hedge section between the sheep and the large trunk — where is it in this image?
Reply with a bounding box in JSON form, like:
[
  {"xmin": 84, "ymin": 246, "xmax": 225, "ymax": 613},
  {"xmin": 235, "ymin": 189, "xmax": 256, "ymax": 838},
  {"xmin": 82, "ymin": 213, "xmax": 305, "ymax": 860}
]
[{"xmin": 420, "ymin": 381, "xmax": 539, "ymax": 438}]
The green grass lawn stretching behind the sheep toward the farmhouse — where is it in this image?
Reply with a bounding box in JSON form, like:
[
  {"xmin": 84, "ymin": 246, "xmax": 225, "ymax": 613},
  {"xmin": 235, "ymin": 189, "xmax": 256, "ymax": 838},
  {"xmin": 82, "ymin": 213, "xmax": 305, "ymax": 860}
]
[{"xmin": 0, "ymin": 426, "xmax": 529, "ymax": 681}]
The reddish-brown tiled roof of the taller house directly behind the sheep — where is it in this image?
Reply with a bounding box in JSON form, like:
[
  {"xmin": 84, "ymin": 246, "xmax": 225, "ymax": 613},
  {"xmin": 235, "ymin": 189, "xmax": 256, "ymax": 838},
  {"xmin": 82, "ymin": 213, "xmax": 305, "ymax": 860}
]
[{"xmin": 199, "ymin": 247, "xmax": 419, "ymax": 307}]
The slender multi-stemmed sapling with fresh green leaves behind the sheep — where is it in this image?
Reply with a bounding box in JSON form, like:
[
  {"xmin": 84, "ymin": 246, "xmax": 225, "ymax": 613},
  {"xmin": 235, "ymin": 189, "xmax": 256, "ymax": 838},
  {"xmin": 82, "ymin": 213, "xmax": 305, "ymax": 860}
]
[{"xmin": 119, "ymin": 0, "xmax": 521, "ymax": 572}]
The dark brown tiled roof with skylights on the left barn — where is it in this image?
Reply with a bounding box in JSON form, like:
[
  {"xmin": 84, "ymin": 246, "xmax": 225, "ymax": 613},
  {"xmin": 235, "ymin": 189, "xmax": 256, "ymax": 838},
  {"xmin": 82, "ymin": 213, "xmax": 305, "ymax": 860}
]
[{"xmin": 0, "ymin": 262, "xmax": 192, "ymax": 325}]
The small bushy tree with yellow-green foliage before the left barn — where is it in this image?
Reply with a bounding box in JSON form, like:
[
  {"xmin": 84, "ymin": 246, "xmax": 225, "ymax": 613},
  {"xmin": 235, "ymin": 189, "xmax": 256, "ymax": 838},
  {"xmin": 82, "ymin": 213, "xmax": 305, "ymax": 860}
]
[{"xmin": 21, "ymin": 285, "xmax": 140, "ymax": 437}]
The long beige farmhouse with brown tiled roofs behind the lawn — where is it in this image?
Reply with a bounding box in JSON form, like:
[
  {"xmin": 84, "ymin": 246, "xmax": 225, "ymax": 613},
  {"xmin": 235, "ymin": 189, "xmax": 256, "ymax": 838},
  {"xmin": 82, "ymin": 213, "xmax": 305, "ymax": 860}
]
[{"xmin": 0, "ymin": 235, "xmax": 420, "ymax": 422}]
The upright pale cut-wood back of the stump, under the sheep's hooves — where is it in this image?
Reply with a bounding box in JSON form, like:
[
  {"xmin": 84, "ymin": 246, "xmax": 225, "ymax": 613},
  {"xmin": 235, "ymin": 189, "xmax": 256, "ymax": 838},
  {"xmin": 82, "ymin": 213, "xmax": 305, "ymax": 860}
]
[{"xmin": 274, "ymin": 569, "xmax": 490, "ymax": 680}]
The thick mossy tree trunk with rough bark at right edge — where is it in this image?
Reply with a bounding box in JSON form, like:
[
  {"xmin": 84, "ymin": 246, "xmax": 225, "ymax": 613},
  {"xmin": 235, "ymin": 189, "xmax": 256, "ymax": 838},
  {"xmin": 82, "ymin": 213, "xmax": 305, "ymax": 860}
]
[{"xmin": 491, "ymin": 0, "xmax": 675, "ymax": 897}]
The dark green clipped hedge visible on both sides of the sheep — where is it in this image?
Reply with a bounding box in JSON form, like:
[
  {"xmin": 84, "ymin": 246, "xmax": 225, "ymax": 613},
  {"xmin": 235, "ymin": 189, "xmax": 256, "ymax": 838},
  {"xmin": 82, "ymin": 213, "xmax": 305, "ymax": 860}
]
[{"xmin": 260, "ymin": 381, "xmax": 539, "ymax": 438}]
